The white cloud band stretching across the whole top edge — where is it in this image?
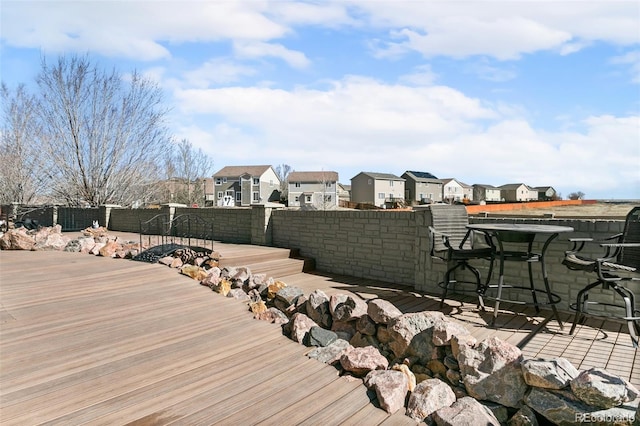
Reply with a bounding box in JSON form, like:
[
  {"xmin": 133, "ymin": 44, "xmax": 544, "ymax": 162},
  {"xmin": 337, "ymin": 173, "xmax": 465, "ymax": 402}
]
[{"xmin": 2, "ymin": 0, "xmax": 640, "ymax": 62}]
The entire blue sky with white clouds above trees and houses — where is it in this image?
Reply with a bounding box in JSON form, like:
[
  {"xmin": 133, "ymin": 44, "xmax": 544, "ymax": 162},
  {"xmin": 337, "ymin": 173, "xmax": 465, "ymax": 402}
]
[{"xmin": 0, "ymin": 0, "xmax": 640, "ymax": 199}]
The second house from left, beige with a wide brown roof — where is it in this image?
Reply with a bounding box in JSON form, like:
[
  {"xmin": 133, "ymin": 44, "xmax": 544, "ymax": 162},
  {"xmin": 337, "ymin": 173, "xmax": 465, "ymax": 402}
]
[{"xmin": 288, "ymin": 171, "xmax": 338, "ymax": 210}]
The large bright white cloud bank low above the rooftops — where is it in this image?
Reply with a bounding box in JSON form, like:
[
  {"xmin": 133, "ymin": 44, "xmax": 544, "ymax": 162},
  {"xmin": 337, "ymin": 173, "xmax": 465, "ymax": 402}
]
[{"xmin": 171, "ymin": 76, "xmax": 640, "ymax": 198}]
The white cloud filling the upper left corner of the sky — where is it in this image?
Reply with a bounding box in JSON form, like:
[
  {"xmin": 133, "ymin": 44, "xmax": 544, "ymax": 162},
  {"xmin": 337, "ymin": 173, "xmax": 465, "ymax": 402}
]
[{"xmin": 2, "ymin": 0, "xmax": 288, "ymax": 60}]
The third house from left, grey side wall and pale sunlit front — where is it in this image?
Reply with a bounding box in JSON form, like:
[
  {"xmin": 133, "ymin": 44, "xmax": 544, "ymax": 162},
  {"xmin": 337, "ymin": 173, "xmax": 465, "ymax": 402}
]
[{"xmin": 351, "ymin": 172, "xmax": 404, "ymax": 207}]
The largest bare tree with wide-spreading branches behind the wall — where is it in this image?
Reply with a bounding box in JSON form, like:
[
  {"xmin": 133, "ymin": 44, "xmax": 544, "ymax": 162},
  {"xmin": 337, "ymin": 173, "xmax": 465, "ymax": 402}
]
[{"xmin": 37, "ymin": 56, "xmax": 170, "ymax": 205}]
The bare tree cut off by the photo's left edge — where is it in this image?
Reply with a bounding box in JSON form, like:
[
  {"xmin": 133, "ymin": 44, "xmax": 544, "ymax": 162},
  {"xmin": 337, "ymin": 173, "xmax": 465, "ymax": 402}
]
[{"xmin": 0, "ymin": 83, "xmax": 50, "ymax": 204}]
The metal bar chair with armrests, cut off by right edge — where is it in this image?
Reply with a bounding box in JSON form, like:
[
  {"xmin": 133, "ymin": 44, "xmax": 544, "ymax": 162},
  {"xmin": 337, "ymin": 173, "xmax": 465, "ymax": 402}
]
[{"xmin": 562, "ymin": 207, "xmax": 640, "ymax": 347}]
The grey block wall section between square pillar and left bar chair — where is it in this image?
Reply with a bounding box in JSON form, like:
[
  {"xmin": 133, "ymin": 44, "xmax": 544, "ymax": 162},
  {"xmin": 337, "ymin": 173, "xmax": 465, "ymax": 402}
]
[{"xmin": 271, "ymin": 210, "xmax": 417, "ymax": 286}]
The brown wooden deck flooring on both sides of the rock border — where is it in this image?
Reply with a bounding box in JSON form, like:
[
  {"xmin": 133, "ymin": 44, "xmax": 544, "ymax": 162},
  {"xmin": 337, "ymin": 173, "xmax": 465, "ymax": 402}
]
[{"xmin": 0, "ymin": 240, "xmax": 640, "ymax": 425}]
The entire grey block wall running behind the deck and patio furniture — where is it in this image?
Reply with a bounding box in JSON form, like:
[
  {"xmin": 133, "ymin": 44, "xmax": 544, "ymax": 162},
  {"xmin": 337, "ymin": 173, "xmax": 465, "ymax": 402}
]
[{"xmin": 109, "ymin": 206, "xmax": 640, "ymax": 311}]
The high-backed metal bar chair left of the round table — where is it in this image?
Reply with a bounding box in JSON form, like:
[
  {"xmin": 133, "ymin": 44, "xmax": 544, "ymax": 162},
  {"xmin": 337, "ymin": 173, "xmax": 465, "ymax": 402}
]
[{"xmin": 429, "ymin": 205, "xmax": 495, "ymax": 310}]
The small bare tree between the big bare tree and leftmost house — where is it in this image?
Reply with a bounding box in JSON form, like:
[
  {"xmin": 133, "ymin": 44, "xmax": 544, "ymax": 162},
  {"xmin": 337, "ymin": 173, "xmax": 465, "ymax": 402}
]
[{"xmin": 167, "ymin": 139, "xmax": 213, "ymax": 205}]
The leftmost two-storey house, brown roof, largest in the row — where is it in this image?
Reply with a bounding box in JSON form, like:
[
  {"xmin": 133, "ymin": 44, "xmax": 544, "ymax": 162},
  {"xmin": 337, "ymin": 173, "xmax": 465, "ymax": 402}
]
[{"xmin": 213, "ymin": 166, "xmax": 280, "ymax": 207}]
